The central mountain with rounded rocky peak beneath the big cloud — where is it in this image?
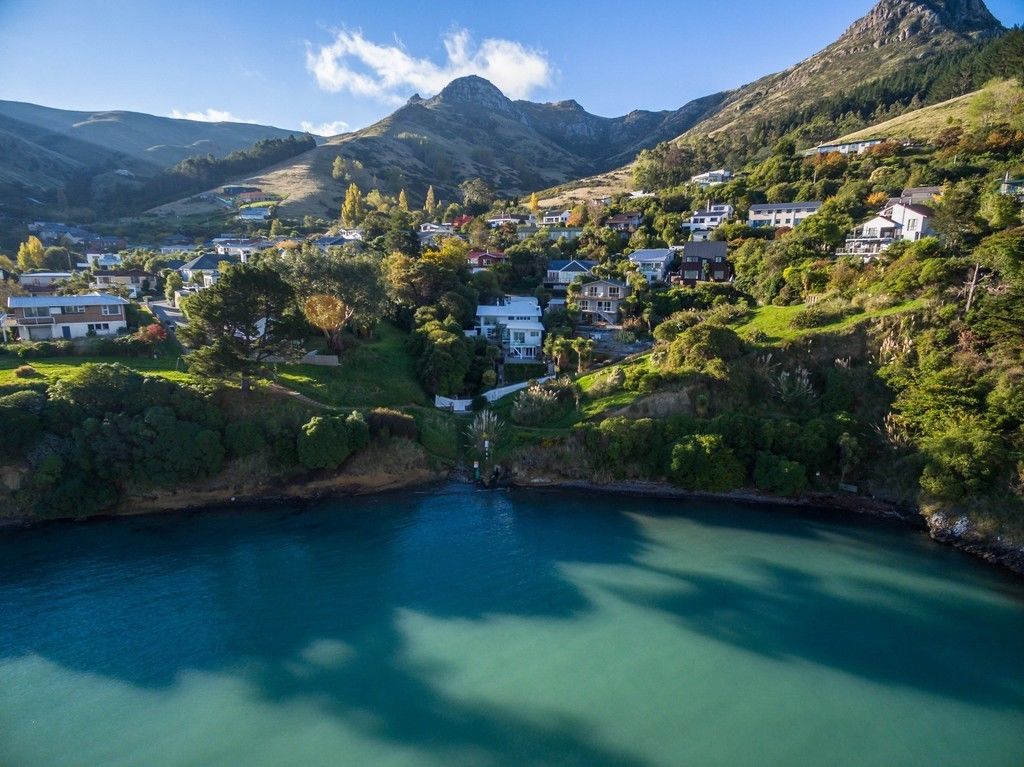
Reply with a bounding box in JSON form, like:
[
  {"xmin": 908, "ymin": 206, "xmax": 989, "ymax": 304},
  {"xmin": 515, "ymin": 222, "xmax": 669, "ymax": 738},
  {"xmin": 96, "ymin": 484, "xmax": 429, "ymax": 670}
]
[{"xmin": 167, "ymin": 76, "xmax": 722, "ymax": 215}]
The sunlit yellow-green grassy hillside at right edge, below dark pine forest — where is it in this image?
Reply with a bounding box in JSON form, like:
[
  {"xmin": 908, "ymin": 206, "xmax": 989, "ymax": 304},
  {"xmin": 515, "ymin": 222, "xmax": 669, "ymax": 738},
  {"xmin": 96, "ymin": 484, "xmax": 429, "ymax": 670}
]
[{"xmin": 839, "ymin": 80, "xmax": 1024, "ymax": 142}]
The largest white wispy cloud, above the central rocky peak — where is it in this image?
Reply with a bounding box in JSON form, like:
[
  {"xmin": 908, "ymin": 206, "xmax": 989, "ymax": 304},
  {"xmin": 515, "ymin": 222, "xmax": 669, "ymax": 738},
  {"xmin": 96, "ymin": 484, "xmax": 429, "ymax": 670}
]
[{"xmin": 306, "ymin": 30, "xmax": 553, "ymax": 103}]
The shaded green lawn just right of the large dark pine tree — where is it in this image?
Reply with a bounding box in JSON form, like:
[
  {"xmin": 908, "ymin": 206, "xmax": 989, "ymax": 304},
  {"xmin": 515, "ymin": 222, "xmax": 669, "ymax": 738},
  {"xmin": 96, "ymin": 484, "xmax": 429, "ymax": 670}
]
[{"xmin": 278, "ymin": 323, "xmax": 429, "ymax": 408}]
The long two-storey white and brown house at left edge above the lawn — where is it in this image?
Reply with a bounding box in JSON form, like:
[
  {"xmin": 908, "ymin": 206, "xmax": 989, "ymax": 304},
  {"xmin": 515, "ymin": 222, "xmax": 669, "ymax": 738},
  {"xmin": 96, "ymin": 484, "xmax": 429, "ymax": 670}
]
[{"xmin": 5, "ymin": 293, "xmax": 128, "ymax": 341}]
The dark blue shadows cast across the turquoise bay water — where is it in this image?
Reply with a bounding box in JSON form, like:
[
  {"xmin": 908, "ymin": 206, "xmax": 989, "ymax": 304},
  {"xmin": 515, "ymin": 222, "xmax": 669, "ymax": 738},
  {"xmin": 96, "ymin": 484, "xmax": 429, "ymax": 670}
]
[{"xmin": 0, "ymin": 487, "xmax": 1024, "ymax": 767}]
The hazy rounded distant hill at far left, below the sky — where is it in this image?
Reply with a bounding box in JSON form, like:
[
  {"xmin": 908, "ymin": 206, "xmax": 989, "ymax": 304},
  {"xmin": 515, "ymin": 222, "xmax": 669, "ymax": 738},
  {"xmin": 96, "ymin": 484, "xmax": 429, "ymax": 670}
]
[{"xmin": 0, "ymin": 100, "xmax": 305, "ymax": 191}]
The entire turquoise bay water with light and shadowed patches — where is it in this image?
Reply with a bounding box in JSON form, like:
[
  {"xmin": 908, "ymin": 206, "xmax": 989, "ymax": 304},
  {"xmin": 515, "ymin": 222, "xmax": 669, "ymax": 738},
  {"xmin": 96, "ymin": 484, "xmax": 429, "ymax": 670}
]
[{"xmin": 0, "ymin": 485, "xmax": 1024, "ymax": 767}]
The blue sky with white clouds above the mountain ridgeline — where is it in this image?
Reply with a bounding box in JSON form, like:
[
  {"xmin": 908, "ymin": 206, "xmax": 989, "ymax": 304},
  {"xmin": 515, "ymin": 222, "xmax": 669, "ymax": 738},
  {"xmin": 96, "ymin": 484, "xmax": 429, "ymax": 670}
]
[{"xmin": 0, "ymin": 0, "xmax": 1024, "ymax": 132}]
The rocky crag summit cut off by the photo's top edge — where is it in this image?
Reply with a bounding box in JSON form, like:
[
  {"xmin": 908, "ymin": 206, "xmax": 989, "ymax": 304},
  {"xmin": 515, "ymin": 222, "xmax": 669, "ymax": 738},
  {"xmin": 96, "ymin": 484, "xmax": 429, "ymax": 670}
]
[{"xmin": 835, "ymin": 0, "xmax": 1004, "ymax": 48}]
